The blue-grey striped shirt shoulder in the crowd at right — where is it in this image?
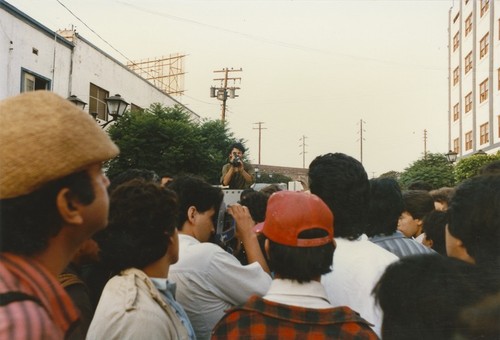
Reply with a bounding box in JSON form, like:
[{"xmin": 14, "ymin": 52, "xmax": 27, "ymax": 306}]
[{"xmin": 370, "ymin": 230, "xmax": 436, "ymax": 258}]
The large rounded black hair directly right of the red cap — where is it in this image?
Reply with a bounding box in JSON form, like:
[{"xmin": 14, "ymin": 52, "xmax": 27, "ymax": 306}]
[{"xmin": 309, "ymin": 153, "xmax": 370, "ymax": 240}]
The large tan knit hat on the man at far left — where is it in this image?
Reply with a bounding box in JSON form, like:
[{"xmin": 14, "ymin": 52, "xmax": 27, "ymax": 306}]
[{"xmin": 0, "ymin": 91, "xmax": 118, "ymax": 199}]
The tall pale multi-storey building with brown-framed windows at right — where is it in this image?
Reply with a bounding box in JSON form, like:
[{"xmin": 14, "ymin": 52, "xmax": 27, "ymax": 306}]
[{"xmin": 448, "ymin": 0, "xmax": 500, "ymax": 157}]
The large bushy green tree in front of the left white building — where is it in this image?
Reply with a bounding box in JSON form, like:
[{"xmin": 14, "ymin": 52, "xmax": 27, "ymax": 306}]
[{"xmin": 107, "ymin": 103, "xmax": 244, "ymax": 184}]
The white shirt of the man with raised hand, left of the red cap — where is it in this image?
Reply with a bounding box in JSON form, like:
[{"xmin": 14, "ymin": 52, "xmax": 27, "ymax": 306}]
[{"xmin": 168, "ymin": 234, "xmax": 271, "ymax": 340}]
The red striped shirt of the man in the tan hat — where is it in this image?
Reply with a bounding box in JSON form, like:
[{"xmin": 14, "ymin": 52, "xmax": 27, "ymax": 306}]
[{"xmin": 0, "ymin": 253, "xmax": 78, "ymax": 340}]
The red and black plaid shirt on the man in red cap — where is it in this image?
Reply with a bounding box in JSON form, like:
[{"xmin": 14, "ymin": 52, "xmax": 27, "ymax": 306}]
[{"xmin": 212, "ymin": 296, "xmax": 378, "ymax": 340}]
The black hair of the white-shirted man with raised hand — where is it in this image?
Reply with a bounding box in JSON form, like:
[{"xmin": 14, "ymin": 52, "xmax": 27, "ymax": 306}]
[{"xmin": 167, "ymin": 175, "xmax": 224, "ymax": 230}]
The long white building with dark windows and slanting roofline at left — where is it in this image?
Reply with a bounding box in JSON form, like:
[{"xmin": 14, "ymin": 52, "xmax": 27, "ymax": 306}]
[{"xmin": 0, "ymin": 0, "xmax": 199, "ymax": 120}]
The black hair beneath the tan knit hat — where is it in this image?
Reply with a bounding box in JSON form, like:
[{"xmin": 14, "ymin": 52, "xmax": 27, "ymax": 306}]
[{"xmin": 0, "ymin": 170, "xmax": 95, "ymax": 256}]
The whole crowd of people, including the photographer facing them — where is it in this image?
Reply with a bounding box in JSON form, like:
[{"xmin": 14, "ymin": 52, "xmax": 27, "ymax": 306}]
[{"xmin": 0, "ymin": 91, "xmax": 500, "ymax": 340}]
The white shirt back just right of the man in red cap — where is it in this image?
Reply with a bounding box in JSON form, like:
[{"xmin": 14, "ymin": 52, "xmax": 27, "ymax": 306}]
[{"xmin": 321, "ymin": 234, "xmax": 398, "ymax": 337}]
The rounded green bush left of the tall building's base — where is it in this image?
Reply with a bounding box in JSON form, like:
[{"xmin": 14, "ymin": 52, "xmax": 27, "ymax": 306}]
[{"xmin": 399, "ymin": 153, "xmax": 455, "ymax": 189}]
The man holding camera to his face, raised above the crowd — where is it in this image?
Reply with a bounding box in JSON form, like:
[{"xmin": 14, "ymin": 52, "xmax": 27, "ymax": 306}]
[{"xmin": 221, "ymin": 143, "xmax": 254, "ymax": 189}]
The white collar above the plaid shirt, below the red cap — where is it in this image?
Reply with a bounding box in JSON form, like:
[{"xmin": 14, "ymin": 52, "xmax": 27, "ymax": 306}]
[{"xmin": 264, "ymin": 279, "xmax": 333, "ymax": 309}]
